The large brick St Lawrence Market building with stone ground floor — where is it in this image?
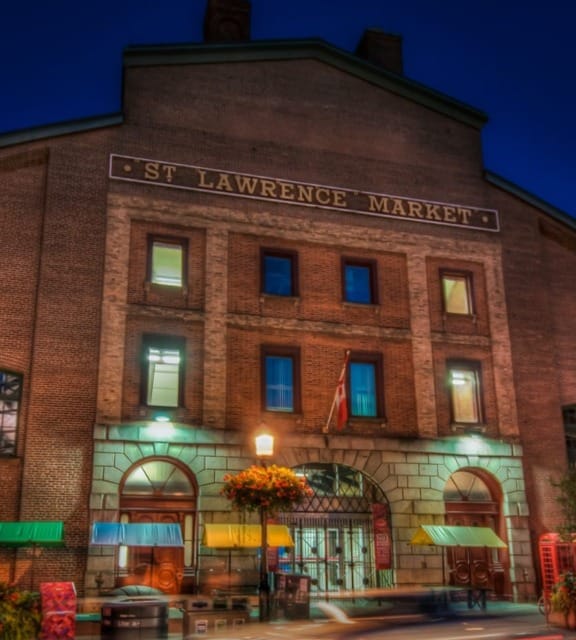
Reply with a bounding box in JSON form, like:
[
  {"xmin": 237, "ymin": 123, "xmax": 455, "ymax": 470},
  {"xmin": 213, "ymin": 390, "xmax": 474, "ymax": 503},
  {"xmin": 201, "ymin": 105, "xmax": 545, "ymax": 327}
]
[{"xmin": 0, "ymin": 2, "xmax": 576, "ymax": 597}]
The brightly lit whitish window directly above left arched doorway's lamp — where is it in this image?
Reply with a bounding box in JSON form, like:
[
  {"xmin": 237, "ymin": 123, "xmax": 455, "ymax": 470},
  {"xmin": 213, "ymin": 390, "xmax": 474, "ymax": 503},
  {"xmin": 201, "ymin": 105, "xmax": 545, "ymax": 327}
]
[{"xmin": 142, "ymin": 335, "xmax": 184, "ymax": 407}]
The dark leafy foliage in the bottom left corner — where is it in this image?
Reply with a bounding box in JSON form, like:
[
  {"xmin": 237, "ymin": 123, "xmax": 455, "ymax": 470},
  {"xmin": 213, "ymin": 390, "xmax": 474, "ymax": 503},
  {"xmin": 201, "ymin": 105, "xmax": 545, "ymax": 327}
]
[{"xmin": 0, "ymin": 582, "xmax": 42, "ymax": 640}]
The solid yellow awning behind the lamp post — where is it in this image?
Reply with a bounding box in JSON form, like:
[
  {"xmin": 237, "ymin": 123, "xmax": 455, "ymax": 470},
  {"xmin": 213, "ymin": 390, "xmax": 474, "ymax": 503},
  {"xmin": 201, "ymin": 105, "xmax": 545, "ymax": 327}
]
[{"xmin": 202, "ymin": 524, "xmax": 294, "ymax": 549}]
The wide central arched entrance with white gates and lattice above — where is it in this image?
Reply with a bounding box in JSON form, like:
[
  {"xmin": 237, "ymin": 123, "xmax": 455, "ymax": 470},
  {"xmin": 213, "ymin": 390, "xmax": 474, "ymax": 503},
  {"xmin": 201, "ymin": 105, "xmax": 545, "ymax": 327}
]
[{"xmin": 280, "ymin": 462, "xmax": 393, "ymax": 592}]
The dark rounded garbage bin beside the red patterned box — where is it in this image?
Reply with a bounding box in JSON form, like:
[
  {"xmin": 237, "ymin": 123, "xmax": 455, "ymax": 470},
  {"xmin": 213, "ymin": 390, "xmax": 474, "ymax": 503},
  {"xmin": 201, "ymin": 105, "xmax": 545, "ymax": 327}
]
[{"xmin": 100, "ymin": 600, "xmax": 168, "ymax": 640}]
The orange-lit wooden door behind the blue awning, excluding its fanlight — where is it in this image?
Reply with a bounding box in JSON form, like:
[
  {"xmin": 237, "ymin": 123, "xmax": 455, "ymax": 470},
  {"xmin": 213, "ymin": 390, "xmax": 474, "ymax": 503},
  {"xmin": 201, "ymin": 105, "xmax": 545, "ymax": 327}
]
[{"xmin": 128, "ymin": 512, "xmax": 184, "ymax": 594}]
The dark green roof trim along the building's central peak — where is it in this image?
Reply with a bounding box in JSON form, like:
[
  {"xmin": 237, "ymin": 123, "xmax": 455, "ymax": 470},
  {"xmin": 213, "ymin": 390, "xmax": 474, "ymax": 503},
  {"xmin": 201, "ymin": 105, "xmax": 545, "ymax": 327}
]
[{"xmin": 124, "ymin": 38, "xmax": 488, "ymax": 129}]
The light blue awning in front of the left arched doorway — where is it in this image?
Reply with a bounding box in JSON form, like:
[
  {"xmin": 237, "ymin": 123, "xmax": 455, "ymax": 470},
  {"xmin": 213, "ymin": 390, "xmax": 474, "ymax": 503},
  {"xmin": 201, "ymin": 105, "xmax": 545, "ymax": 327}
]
[{"xmin": 90, "ymin": 522, "xmax": 184, "ymax": 547}]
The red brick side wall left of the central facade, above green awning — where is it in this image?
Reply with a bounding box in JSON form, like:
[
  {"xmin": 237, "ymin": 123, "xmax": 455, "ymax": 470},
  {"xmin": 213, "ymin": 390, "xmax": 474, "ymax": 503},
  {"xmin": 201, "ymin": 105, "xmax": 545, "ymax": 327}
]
[{"xmin": 0, "ymin": 134, "xmax": 112, "ymax": 585}]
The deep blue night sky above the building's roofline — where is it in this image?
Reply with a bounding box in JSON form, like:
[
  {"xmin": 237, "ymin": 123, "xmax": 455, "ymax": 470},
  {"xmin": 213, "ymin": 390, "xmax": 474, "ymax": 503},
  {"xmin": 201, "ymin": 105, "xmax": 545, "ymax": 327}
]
[{"xmin": 0, "ymin": 0, "xmax": 576, "ymax": 217}]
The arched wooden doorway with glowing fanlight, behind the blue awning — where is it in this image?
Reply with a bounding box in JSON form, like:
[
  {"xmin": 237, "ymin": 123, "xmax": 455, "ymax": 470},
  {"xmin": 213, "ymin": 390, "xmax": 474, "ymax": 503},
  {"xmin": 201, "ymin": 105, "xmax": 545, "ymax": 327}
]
[{"xmin": 118, "ymin": 458, "xmax": 197, "ymax": 594}]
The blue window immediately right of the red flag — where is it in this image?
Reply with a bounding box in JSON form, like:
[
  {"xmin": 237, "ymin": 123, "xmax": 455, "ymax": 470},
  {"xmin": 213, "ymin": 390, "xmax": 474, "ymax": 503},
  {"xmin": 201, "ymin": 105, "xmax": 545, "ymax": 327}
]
[{"xmin": 348, "ymin": 354, "xmax": 382, "ymax": 418}]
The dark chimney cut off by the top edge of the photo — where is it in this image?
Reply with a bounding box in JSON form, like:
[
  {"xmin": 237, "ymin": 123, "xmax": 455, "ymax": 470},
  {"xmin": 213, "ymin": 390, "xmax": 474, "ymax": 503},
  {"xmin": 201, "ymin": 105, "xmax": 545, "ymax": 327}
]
[{"xmin": 204, "ymin": 0, "xmax": 251, "ymax": 42}]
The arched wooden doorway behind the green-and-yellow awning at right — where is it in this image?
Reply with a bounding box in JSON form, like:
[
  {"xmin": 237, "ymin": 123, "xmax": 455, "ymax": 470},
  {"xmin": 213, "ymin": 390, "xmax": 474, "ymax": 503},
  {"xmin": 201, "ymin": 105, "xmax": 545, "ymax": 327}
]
[{"xmin": 444, "ymin": 469, "xmax": 508, "ymax": 597}]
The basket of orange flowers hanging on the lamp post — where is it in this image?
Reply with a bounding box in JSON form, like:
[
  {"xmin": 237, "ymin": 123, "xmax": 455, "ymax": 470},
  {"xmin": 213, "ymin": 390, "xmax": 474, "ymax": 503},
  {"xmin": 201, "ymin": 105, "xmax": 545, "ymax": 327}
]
[{"xmin": 221, "ymin": 465, "xmax": 313, "ymax": 513}]
